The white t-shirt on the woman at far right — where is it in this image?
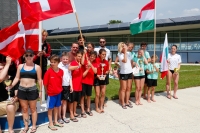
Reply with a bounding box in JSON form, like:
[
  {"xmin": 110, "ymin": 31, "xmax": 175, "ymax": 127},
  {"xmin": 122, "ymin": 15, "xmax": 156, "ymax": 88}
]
[{"xmin": 168, "ymin": 53, "xmax": 182, "ymax": 70}]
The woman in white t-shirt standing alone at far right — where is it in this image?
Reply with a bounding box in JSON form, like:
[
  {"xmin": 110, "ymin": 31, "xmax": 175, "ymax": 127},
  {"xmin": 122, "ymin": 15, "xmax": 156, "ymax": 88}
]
[{"xmin": 166, "ymin": 45, "xmax": 182, "ymax": 99}]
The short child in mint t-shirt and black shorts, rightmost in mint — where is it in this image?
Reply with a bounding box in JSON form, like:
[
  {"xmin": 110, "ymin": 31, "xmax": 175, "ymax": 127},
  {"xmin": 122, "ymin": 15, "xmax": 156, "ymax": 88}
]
[{"xmin": 146, "ymin": 55, "xmax": 160, "ymax": 103}]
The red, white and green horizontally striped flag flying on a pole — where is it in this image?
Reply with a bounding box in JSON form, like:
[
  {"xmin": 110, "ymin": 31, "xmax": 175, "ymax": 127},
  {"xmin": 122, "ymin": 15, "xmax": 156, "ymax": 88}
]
[{"xmin": 130, "ymin": 0, "xmax": 155, "ymax": 35}]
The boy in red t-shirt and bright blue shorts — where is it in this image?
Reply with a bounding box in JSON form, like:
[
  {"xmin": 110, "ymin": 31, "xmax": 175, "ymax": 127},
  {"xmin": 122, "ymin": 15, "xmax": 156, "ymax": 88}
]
[{"xmin": 43, "ymin": 55, "xmax": 64, "ymax": 131}]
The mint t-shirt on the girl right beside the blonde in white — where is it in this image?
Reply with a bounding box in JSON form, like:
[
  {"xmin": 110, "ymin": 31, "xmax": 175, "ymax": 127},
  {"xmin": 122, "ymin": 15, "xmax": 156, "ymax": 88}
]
[{"xmin": 133, "ymin": 57, "xmax": 145, "ymax": 76}]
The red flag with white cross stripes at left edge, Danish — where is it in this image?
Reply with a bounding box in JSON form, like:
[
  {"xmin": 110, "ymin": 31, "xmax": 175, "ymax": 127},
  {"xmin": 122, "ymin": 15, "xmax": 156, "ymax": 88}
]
[{"xmin": 0, "ymin": 21, "xmax": 38, "ymax": 60}]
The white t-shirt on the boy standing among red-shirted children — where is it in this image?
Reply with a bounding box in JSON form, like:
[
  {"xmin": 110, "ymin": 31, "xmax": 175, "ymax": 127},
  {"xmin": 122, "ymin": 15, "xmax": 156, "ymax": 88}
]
[{"xmin": 58, "ymin": 62, "xmax": 72, "ymax": 86}]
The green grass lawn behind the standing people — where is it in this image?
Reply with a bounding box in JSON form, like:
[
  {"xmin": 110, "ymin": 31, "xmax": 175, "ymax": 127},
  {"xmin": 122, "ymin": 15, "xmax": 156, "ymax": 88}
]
[{"xmin": 92, "ymin": 66, "xmax": 200, "ymax": 100}]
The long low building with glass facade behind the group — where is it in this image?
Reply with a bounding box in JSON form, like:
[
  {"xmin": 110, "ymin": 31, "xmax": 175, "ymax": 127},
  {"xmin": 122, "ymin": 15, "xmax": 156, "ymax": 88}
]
[{"xmin": 48, "ymin": 16, "xmax": 200, "ymax": 63}]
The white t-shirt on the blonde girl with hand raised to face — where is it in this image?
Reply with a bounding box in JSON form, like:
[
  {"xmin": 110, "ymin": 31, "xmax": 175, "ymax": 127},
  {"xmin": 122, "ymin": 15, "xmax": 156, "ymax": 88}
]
[{"xmin": 117, "ymin": 52, "xmax": 132, "ymax": 74}]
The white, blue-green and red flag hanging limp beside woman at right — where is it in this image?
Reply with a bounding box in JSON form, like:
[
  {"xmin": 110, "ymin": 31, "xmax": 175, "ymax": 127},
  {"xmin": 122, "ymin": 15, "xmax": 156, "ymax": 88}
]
[{"xmin": 160, "ymin": 33, "xmax": 169, "ymax": 79}]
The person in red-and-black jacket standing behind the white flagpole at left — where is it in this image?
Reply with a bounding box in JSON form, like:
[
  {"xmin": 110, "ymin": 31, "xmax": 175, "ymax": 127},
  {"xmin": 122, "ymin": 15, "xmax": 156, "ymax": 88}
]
[{"xmin": 33, "ymin": 30, "xmax": 51, "ymax": 79}]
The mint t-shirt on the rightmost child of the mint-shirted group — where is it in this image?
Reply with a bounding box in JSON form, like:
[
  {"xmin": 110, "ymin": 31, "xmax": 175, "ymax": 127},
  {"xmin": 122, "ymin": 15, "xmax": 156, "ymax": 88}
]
[{"xmin": 145, "ymin": 63, "xmax": 160, "ymax": 79}]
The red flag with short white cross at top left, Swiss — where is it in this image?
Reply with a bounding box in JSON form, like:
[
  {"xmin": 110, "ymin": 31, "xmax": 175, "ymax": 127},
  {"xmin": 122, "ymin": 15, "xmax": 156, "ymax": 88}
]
[{"xmin": 18, "ymin": 0, "xmax": 76, "ymax": 23}]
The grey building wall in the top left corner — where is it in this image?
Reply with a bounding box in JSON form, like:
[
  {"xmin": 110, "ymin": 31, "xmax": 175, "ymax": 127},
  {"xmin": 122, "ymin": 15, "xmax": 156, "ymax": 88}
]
[{"xmin": 0, "ymin": 0, "xmax": 18, "ymax": 29}]
